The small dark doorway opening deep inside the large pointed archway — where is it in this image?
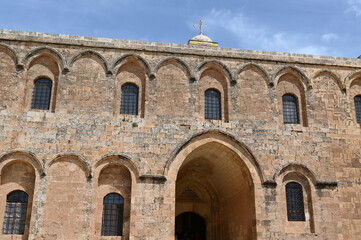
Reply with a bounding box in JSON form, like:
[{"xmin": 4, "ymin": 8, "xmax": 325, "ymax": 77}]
[{"xmin": 175, "ymin": 212, "xmax": 206, "ymax": 240}]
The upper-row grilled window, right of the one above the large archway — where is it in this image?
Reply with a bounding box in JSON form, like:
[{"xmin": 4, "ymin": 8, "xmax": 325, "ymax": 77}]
[{"xmin": 282, "ymin": 94, "xmax": 300, "ymax": 124}]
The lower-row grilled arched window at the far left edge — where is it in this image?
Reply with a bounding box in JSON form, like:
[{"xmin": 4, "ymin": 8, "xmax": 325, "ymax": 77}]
[{"xmin": 3, "ymin": 190, "xmax": 28, "ymax": 234}]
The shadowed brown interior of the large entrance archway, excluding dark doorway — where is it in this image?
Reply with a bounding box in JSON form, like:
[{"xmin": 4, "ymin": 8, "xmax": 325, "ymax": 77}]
[{"xmin": 175, "ymin": 141, "xmax": 256, "ymax": 240}]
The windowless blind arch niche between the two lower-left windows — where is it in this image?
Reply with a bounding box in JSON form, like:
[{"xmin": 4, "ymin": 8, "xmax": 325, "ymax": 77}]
[{"xmin": 42, "ymin": 153, "xmax": 92, "ymax": 239}]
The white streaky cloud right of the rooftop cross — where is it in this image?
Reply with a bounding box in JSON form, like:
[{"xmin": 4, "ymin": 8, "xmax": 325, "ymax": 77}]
[{"xmin": 204, "ymin": 9, "xmax": 337, "ymax": 55}]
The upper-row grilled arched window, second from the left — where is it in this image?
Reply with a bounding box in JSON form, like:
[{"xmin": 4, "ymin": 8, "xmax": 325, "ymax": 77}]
[{"xmin": 120, "ymin": 83, "xmax": 139, "ymax": 115}]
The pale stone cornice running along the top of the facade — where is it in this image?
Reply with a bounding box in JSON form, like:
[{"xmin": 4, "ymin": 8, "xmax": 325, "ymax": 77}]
[{"xmin": 0, "ymin": 30, "xmax": 361, "ymax": 68}]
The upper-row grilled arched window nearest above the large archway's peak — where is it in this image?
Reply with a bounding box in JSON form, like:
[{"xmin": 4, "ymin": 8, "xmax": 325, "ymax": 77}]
[{"xmin": 204, "ymin": 89, "xmax": 222, "ymax": 120}]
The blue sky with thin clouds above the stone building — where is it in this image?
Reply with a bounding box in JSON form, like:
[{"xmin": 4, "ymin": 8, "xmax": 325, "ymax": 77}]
[{"xmin": 0, "ymin": 0, "xmax": 361, "ymax": 58}]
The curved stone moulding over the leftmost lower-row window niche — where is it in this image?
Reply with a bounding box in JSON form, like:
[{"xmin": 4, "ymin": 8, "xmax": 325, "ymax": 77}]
[{"xmin": 0, "ymin": 150, "xmax": 44, "ymax": 176}]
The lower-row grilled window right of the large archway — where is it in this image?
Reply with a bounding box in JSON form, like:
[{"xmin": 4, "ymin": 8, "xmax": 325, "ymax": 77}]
[{"xmin": 286, "ymin": 182, "xmax": 305, "ymax": 221}]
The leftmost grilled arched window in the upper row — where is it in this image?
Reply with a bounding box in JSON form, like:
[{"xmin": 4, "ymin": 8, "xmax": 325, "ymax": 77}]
[{"xmin": 31, "ymin": 78, "xmax": 53, "ymax": 110}]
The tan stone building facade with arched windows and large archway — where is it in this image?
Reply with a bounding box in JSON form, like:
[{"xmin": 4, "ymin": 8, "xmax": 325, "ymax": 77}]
[{"xmin": 0, "ymin": 30, "xmax": 361, "ymax": 240}]
